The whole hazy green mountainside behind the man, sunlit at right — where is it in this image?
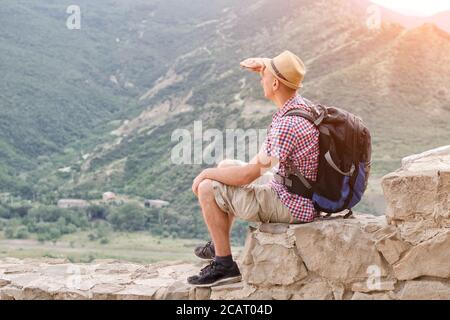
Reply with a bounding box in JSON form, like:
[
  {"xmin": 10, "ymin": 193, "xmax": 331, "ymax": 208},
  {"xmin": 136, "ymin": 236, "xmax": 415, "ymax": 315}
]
[{"xmin": 0, "ymin": 0, "xmax": 450, "ymax": 225}]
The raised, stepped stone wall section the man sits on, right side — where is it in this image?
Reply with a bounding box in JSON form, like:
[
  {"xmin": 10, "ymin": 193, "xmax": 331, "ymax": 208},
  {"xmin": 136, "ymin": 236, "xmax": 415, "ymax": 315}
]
[{"xmin": 222, "ymin": 147, "xmax": 450, "ymax": 299}]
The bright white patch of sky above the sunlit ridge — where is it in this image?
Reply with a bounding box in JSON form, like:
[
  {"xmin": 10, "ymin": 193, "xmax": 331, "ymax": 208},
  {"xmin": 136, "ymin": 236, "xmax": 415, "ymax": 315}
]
[{"xmin": 371, "ymin": 0, "xmax": 450, "ymax": 16}]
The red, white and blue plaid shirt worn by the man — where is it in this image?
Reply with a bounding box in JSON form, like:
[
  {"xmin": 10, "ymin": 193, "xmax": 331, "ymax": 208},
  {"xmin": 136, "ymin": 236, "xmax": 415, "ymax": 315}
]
[{"xmin": 264, "ymin": 95, "xmax": 319, "ymax": 222}]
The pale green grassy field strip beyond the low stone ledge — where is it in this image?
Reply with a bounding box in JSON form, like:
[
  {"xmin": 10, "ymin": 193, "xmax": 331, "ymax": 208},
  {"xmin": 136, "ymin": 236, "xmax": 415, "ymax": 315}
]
[{"xmin": 0, "ymin": 232, "xmax": 241, "ymax": 263}]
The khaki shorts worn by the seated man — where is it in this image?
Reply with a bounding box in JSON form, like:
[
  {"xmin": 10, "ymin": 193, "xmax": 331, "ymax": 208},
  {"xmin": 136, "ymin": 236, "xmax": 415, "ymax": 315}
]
[{"xmin": 212, "ymin": 160, "xmax": 294, "ymax": 223}]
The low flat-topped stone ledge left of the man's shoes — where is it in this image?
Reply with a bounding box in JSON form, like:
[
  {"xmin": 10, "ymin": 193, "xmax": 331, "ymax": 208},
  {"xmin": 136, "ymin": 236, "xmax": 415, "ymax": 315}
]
[{"xmin": 0, "ymin": 258, "xmax": 199, "ymax": 300}]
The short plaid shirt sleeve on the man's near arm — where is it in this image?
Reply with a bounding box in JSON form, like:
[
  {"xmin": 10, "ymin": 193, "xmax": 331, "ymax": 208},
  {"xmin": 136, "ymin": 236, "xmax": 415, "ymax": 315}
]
[{"xmin": 264, "ymin": 118, "xmax": 297, "ymax": 162}]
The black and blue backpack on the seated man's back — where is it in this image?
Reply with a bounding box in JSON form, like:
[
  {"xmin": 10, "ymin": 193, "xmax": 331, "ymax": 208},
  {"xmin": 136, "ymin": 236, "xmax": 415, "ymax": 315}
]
[{"xmin": 275, "ymin": 99, "xmax": 372, "ymax": 218}]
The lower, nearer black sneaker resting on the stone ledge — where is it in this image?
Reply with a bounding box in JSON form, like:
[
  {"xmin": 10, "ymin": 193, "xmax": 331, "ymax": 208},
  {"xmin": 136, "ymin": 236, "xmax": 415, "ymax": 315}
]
[{"xmin": 188, "ymin": 260, "xmax": 242, "ymax": 287}]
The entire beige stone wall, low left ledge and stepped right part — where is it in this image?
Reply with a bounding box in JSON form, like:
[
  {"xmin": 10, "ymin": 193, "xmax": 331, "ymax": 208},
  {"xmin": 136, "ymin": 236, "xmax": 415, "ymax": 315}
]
[{"xmin": 0, "ymin": 147, "xmax": 450, "ymax": 300}]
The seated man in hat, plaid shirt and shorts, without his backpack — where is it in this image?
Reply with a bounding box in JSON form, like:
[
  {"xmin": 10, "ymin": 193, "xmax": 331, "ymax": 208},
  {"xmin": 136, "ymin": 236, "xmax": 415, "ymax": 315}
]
[{"xmin": 188, "ymin": 51, "xmax": 319, "ymax": 287}]
